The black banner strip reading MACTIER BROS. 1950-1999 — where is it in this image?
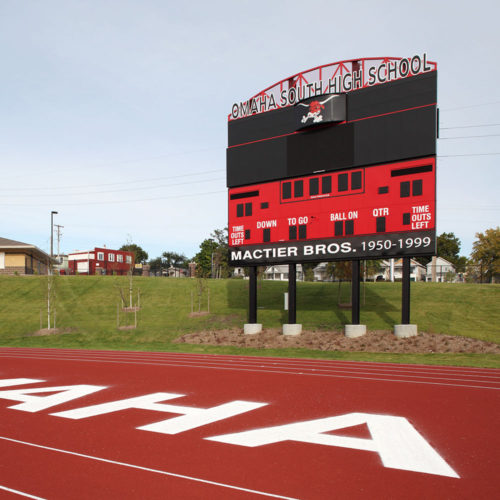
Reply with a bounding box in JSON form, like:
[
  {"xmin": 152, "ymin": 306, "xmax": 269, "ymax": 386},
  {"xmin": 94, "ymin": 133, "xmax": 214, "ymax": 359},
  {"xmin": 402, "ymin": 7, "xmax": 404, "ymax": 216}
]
[{"xmin": 229, "ymin": 230, "xmax": 436, "ymax": 266}]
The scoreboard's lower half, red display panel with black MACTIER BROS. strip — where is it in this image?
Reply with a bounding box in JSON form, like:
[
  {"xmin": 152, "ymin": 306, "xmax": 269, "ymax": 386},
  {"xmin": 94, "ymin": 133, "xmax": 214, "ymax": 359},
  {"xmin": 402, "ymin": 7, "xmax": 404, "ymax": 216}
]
[{"xmin": 228, "ymin": 157, "xmax": 436, "ymax": 265}]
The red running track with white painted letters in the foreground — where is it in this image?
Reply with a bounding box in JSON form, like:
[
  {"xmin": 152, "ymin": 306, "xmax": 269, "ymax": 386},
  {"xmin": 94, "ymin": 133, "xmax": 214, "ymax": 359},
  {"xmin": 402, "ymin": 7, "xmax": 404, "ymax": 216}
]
[{"xmin": 0, "ymin": 348, "xmax": 500, "ymax": 499}]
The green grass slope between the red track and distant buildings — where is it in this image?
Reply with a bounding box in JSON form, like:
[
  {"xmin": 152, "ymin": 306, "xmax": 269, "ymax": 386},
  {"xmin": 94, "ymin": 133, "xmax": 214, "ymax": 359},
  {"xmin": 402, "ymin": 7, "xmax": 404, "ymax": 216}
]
[{"xmin": 0, "ymin": 276, "xmax": 500, "ymax": 367}]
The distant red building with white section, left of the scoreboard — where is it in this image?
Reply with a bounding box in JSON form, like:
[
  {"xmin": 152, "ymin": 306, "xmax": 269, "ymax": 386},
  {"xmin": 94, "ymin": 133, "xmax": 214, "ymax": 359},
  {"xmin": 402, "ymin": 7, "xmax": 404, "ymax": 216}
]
[{"xmin": 68, "ymin": 247, "xmax": 134, "ymax": 275}]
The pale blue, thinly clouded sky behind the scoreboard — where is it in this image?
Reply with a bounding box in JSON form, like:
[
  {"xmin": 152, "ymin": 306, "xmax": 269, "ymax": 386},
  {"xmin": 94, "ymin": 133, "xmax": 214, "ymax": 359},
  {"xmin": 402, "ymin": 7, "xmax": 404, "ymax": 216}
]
[{"xmin": 0, "ymin": 0, "xmax": 500, "ymax": 258}]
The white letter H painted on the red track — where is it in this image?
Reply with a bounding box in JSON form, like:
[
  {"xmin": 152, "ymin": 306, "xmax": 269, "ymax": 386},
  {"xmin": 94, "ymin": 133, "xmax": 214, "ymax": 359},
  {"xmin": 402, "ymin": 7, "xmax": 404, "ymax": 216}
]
[{"xmin": 52, "ymin": 392, "xmax": 267, "ymax": 434}]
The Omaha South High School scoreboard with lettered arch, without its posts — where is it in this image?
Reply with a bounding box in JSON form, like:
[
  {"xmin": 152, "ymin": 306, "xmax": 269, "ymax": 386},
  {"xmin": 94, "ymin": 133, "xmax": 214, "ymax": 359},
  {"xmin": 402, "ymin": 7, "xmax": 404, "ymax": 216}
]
[{"xmin": 227, "ymin": 56, "xmax": 437, "ymax": 266}]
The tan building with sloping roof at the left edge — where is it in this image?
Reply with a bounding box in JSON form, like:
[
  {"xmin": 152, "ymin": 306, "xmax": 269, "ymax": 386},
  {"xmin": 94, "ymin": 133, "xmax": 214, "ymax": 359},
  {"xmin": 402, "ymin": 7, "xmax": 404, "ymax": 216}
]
[{"xmin": 0, "ymin": 238, "xmax": 54, "ymax": 275}]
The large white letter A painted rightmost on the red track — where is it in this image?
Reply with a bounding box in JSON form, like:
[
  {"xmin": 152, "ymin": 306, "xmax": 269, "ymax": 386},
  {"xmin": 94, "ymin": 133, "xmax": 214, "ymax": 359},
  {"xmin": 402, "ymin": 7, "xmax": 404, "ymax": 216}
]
[{"xmin": 206, "ymin": 413, "xmax": 459, "ymax": 478}]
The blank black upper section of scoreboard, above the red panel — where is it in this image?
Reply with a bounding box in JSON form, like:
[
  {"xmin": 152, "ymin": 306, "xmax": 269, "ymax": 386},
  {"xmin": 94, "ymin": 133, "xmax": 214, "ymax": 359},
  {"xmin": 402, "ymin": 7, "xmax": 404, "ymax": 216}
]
[{"xmin": 227, "ymin": 71, "xmax": 437, "ymax": 187}]
